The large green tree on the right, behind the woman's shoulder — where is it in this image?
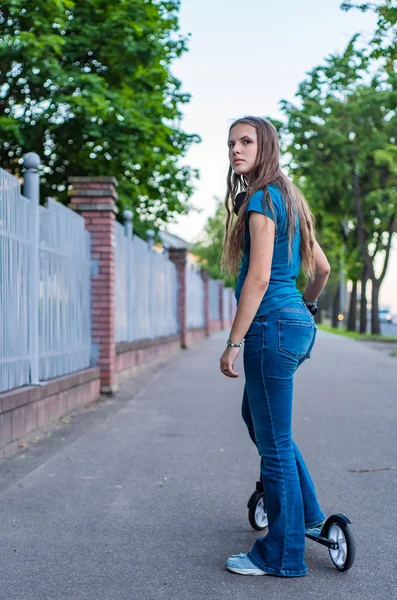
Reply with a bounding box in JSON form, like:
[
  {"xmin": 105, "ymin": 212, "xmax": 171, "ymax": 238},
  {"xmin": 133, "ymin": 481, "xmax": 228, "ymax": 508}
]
[{"xmin": 283, "ymin": 38, "xmax": 397, "ymax": 333}]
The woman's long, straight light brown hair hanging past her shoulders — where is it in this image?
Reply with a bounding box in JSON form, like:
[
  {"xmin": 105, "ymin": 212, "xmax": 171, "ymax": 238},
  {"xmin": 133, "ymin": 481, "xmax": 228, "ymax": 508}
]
[{"xmin": 221, "ymin": 117, "xmax": 315, "ymax": 279}]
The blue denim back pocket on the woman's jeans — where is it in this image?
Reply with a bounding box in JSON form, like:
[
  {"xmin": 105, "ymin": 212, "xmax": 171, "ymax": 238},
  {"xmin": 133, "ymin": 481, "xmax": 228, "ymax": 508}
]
[{"xmin": 277, "ymin": 318, "xmax": 314, "ymax": 359}]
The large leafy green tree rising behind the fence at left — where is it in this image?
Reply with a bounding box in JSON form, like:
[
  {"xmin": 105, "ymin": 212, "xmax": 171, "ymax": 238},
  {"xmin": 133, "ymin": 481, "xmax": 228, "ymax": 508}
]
[{"xmin": 0, "ymin": 0, "xmax": 199, "ymax": 238}]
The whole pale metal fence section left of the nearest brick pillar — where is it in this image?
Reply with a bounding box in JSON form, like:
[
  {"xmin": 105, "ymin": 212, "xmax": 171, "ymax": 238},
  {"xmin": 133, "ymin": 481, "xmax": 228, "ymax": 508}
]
[{"xmin": 0, "ymin": 169, "xmax": 91, "ymax": 392}]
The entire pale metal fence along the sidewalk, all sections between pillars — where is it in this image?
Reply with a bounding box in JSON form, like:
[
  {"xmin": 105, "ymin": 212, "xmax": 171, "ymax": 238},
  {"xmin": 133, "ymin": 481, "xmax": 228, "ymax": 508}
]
[{"xmin": 0, "ymin": 162, "xmax": 234, "ymax": 392}]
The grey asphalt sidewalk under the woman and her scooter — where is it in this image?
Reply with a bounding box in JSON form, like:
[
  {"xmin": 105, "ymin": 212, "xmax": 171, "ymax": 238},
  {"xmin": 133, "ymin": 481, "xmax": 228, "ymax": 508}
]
[{"xmin": 0, "ymin": 332, "xmax": 397, "ymax": 600}]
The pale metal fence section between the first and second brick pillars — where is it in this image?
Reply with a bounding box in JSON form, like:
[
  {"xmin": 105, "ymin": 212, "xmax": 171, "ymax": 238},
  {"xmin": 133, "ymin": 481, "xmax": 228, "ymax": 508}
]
[{"xmin": 115, "ymin": 221, "xmax": 179, "ymax": 342}]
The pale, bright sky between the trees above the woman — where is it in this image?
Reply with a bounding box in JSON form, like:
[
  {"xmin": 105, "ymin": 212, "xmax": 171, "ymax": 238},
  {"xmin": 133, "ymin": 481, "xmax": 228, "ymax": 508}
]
[{"xmin": 168, "ymin": 0, "xmax": 397, "ymax": 313}]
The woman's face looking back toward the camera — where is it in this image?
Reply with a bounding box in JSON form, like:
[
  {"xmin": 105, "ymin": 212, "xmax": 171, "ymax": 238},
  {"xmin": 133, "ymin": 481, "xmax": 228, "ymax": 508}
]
[{"xmin": 228, "ymin": 123, "xmax": 258, "ymax": 176}]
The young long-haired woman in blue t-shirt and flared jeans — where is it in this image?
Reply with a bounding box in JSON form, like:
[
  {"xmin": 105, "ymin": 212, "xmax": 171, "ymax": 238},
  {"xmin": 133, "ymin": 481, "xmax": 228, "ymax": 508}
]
[{"xmin": 220, "ymin": 117, "xmax": 330, "ymax": 577}]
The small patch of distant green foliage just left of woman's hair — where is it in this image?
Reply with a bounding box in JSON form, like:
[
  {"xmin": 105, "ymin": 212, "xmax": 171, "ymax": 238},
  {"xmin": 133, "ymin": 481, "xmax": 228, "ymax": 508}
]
[{"xmin": 191, "ymin": 199, "xmax": 237, "ymax": 288}]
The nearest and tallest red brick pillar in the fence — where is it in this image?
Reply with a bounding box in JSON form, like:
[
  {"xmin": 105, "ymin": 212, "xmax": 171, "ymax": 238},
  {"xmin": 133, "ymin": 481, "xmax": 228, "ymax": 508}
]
[{"xmin": 68, "ymin": 177, "xmax": 117, "ymax": 394}]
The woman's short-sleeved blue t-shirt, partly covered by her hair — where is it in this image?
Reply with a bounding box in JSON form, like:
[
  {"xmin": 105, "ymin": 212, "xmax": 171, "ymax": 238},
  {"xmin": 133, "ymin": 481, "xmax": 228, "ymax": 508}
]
[{"xmin": 235, "ymin": 184, "xmax": 302, "ymax": 317}]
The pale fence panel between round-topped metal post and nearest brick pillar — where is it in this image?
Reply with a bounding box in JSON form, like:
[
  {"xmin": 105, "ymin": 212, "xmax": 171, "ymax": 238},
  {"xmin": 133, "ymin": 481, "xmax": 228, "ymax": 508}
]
[{"xmin": 38, "ymin": 198, "xmax": 91, "ymax": 381}]
